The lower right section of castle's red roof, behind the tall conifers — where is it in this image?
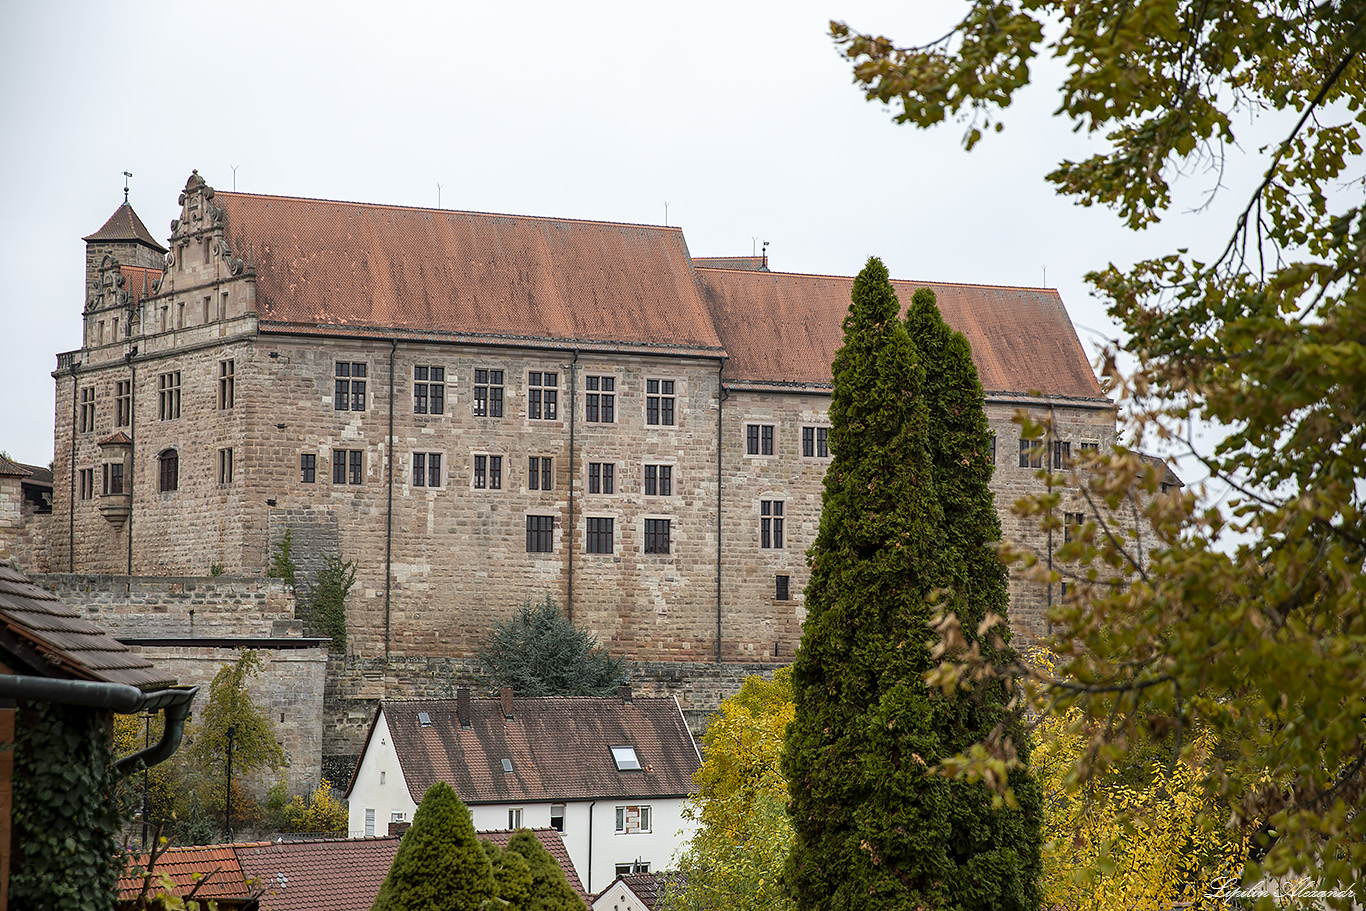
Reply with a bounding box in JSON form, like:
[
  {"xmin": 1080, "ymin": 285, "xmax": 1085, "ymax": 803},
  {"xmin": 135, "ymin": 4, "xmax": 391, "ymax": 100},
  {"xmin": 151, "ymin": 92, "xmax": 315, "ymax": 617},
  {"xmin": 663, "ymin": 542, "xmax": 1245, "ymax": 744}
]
[{"xmin": 697, "ymin": 268, "xmax": 1104, "ymax": 399}]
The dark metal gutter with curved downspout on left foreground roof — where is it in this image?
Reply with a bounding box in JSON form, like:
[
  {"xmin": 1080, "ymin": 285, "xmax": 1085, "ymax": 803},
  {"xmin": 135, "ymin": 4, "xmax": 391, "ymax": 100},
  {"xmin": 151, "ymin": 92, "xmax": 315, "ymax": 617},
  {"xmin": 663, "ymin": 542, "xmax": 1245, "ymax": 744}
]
[{"xmin": 0, "ymin": 673, "xmax": 199, "ymax": 777}]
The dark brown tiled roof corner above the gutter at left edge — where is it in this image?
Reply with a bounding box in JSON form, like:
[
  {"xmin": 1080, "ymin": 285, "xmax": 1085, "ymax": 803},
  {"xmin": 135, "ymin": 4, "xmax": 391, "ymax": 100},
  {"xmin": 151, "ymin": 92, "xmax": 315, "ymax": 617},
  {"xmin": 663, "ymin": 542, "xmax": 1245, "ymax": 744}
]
[{"xmin": 0, "ymin": 564, "xmax": 175, "ymax": 690}]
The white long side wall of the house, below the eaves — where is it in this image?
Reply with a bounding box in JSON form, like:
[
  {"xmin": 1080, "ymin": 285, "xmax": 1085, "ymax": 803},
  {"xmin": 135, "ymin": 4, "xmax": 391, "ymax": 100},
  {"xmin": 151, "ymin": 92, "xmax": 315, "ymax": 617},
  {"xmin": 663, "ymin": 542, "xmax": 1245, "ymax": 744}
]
[{"xmin": 470, "ymin": 798, "xmax": 697, "ymax": 893}]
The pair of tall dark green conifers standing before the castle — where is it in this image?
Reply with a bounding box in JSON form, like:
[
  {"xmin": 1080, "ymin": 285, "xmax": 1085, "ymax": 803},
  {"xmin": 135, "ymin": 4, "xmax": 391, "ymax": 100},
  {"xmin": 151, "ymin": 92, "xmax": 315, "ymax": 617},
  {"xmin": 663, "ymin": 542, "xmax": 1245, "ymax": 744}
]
[{"xmin": 784, "ymin": 258, "xmax": 1038, "ymax": 911}]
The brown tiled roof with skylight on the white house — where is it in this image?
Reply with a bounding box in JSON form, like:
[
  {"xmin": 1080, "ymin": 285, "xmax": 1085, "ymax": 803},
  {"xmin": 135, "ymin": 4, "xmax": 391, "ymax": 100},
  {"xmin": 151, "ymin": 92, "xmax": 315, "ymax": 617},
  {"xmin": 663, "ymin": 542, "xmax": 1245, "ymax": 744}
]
[{"xmin": 347, "ymin": 695, "xmax": 702, "ymax": 803}]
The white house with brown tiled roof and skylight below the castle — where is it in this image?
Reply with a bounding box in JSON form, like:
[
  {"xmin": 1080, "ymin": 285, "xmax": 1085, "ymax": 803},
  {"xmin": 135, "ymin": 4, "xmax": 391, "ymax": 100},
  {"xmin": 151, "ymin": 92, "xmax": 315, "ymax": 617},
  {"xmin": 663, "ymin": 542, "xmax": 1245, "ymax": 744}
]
[{"xmin": 346, "ymin": 687, "xmax": 702, "ymax": 895}]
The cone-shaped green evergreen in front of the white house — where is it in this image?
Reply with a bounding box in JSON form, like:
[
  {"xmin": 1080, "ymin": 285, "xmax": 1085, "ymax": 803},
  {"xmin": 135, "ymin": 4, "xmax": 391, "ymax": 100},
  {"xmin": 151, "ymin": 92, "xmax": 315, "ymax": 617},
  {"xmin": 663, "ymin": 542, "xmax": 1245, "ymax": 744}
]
[{"xmin": 373, "ymin": 781, "xmax": 496, "ymax": 911}]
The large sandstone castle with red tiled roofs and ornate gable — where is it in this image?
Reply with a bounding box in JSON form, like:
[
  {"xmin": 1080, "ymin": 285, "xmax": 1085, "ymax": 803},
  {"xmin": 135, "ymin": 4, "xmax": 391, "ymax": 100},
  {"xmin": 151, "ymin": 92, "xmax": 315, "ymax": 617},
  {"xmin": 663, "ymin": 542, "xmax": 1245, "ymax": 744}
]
[{"xmin": 46, "ymin": 172, "xmax": 1115, "ymax": 662}]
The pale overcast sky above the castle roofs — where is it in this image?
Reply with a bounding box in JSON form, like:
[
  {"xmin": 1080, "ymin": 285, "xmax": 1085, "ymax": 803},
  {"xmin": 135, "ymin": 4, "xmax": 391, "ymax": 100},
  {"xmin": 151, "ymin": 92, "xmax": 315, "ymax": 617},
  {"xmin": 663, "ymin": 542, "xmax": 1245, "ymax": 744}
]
[{"xmin": 0, "ymin": 0, "xmax": 1257, "ymax": 478}]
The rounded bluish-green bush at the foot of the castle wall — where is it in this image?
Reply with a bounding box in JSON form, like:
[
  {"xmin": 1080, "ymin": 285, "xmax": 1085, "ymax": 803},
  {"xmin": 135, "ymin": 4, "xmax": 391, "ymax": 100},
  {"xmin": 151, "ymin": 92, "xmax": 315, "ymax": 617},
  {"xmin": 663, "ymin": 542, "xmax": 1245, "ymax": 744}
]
[{"xmin": 478, "ymin": 597, "xmax": 626, "ymax": 697}]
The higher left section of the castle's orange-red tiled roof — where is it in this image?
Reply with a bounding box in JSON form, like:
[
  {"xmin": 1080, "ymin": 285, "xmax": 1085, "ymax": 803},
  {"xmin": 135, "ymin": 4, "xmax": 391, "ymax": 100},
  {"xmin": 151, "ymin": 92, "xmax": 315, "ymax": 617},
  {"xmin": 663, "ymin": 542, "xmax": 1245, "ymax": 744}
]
[{"xmin": 214, "ymin": 193, "xmax": 720, "ymax": 352}]
